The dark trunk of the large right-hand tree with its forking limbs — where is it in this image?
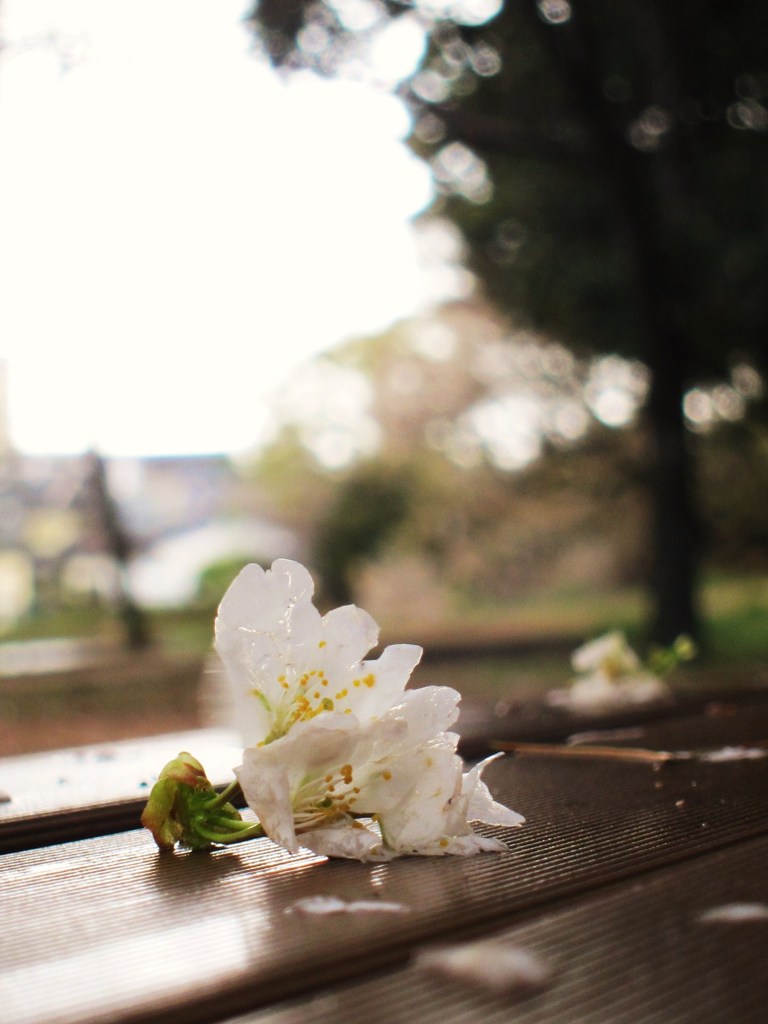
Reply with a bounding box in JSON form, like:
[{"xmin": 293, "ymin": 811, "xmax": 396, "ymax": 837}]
[{"xmin": 525, "ymin": 0, "xmax": 700, "ymax": 643}]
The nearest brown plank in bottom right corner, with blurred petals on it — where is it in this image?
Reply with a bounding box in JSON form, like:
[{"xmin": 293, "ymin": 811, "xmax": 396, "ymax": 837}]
[{"xmin": 228, "ymin": 839, "xmax": 768, "ymax": 1024}]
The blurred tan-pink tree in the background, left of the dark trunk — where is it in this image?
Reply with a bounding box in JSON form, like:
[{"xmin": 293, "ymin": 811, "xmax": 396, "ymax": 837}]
[{"xmin": 250, "ymin": 302, "xmax": 663, "ymax": 606}]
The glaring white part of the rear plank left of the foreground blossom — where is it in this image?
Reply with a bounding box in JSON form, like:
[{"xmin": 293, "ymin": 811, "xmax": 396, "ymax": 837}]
[{"xmin": 0, "ymin": 729, "xmax": 241, "ymax": 853}]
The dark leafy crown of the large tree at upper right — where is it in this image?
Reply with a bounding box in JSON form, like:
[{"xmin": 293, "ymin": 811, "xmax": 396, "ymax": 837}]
[{"xmin": 436, "ymin": 0, "xmax": 768, "ymax": 383}]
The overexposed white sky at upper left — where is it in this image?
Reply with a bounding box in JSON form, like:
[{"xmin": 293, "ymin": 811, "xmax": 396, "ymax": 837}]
[{"xmin": 0, "ymin": 0, "xmax": 438, "ymax": 455}]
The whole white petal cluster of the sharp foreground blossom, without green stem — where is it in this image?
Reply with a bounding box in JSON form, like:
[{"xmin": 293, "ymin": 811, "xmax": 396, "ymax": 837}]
[{"xmin": 216, "ymin": 559, "xmax": 523, "ymax": 860}]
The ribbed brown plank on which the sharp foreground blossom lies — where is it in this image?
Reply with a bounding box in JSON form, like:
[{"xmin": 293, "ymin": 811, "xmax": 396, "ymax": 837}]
[{"xmin": 0, "ymin": 759, "xmax": 768, "ymax": 1024}]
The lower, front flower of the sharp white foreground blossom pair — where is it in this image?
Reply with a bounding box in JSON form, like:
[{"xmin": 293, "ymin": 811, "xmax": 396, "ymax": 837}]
[{"xmin": 237, "ymin": 687, "xmax": 523, "ymax": 860}]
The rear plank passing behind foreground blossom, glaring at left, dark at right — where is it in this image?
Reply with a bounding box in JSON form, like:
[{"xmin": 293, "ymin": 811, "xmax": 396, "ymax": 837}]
[{"xmin": 0, "ymin": 700, "xmax": 768, "ymax": 852}]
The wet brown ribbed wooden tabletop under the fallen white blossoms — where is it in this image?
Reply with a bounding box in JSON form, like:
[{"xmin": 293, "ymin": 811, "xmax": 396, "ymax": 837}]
[{"xmin": 0, "ymin": 699, "xmax": 768, "ymax": 1024}]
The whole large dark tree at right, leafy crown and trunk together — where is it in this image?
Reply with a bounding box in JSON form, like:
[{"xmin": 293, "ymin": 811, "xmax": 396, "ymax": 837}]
[{"xmin": 246, "ymin": 0, "xmax": 768, "ymax": 642}]
